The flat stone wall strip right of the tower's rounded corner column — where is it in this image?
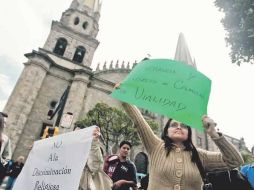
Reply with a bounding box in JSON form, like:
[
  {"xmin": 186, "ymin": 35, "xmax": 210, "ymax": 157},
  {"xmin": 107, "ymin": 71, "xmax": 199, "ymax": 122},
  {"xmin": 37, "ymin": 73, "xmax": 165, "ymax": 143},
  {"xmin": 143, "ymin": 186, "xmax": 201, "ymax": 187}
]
[{"xmin": 13, "ymin": 64, "xmax": 72, "ymax": 158}]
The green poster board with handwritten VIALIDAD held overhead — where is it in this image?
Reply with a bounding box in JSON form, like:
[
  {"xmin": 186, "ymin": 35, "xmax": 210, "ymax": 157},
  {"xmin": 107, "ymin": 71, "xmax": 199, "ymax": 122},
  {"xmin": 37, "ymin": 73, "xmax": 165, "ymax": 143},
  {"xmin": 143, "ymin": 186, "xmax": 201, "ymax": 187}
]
[{"xmin": 111, "ymin": 59, "xmax": 211, "ymax": 129}]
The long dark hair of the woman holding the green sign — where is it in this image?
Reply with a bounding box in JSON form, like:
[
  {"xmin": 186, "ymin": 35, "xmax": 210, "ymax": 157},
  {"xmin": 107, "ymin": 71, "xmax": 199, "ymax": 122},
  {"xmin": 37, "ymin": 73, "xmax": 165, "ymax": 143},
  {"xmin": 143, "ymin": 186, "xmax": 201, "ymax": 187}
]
[{"xmin": 161, "ymin": 119, "xmax": 198, "ymax": 162}]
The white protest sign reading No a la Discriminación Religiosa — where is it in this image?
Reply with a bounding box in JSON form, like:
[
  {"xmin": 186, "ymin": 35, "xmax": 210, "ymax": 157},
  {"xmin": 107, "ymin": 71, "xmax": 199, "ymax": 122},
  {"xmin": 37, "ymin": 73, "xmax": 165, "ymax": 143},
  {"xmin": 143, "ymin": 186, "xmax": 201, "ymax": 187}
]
[{"xmin": 13, "ymin": 126, "xmax": 95, "ymax": 190}]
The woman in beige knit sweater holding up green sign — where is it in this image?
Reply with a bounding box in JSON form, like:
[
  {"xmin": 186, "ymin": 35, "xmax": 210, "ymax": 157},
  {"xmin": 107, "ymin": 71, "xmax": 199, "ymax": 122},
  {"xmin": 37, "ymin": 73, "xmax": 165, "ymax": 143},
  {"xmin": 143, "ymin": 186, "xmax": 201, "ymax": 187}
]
[{"xmin": 116, "ymin": 85, "xmax": 243, "ymax": 190}]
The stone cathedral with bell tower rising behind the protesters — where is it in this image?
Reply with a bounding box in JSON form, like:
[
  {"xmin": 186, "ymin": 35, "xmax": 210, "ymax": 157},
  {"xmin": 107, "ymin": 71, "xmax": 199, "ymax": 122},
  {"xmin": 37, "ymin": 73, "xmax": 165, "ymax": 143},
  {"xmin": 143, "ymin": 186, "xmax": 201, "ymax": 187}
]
[{"xmin": 4, "ymin": 0, "xmax": 247, "ymax": 175}]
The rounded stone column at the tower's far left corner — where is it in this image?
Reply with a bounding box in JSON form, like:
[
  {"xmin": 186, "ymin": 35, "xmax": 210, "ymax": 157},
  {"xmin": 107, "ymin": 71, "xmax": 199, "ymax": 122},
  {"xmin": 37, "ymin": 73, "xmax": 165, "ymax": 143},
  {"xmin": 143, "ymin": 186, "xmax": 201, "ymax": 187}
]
[{"xmin": 4, "ymin": 57, "xmax": 49, "ymax": 154}]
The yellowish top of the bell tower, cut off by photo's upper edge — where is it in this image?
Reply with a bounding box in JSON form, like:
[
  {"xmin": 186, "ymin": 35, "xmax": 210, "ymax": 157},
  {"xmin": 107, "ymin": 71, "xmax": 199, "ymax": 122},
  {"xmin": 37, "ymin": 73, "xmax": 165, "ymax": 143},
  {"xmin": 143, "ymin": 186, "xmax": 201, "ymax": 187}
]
[{"xmin": 71, "ymin": 0, "xmax": 101, "ymax": 12}]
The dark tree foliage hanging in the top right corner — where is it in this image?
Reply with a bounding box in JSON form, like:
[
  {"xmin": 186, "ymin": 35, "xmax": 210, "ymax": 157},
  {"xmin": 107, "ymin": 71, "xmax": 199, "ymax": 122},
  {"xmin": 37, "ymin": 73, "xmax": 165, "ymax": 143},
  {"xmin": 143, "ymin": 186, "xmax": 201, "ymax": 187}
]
[{"xmin": 215, "ymin": 0, "xmax": 254, "ymax": 65}]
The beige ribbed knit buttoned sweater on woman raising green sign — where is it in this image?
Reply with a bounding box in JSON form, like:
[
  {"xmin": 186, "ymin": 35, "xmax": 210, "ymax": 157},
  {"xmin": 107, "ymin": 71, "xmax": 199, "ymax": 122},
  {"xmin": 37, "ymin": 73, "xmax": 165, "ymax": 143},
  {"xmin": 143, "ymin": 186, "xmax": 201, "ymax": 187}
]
[{"xmin": 123, "ymin": 103, "xmax": 243, "ymax": 190}]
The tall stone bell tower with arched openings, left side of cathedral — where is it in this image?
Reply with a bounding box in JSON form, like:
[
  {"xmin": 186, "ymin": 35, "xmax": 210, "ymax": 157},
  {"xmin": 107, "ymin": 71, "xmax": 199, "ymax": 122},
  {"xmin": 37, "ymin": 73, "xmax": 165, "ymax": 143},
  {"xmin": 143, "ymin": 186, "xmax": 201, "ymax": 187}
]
[{"xmin": 4, "ymin": 0, "xmax": 101, "ymax": 158}]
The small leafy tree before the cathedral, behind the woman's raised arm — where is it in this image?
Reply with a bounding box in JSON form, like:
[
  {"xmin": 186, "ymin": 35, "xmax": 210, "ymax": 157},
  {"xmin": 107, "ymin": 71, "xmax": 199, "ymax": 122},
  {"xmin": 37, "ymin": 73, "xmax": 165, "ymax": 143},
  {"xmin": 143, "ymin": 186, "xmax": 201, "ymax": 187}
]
[{"xmin": 75, "ymin": 103, "xmax": 158, "ymax": 153}]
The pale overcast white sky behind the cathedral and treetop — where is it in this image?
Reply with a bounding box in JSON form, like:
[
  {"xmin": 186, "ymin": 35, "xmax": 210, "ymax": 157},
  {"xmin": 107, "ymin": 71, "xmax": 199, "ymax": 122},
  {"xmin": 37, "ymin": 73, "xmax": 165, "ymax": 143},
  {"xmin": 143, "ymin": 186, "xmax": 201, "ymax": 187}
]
[{"xmin": 0, "ymin": 0, "xmax": 254, "ymax": 149}]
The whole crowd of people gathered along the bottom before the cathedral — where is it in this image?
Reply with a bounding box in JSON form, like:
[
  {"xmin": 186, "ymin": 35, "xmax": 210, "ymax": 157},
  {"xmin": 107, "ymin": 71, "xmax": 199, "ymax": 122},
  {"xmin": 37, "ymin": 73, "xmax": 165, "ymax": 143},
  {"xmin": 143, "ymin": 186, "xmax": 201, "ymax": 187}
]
[{"xmin": 0, "ymin": 94, "xmax": 254, "ymax": 190}]
